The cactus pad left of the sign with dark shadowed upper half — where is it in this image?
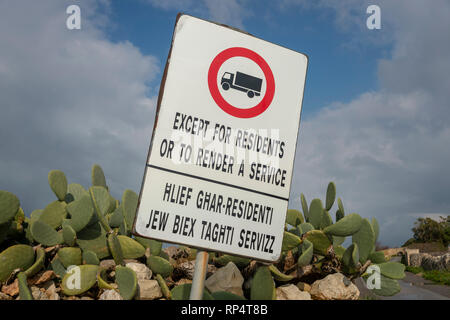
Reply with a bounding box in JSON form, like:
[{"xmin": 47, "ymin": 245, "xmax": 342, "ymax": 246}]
[{"xmin": 77, "ymin": 223, "xmax": 110, "ymax": 259}]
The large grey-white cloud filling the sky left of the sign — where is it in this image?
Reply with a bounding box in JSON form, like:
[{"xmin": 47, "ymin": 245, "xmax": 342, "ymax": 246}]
[{"xmin": 0, "ymin": 0, "xmax": 159, "ymax": 213}]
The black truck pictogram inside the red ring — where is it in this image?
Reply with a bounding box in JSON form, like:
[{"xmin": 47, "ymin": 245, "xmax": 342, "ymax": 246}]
[{"xmin": 220, "ymin": 71, "xmax": 262, "ymax": 98}]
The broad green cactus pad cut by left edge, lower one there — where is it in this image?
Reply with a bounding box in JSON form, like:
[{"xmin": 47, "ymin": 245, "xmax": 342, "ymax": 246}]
[{"xmin": 0, "ymin": 244, "xmax": 35, "ymax": 283}]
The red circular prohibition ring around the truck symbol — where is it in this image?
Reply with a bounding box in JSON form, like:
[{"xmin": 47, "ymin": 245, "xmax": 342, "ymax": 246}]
[{"xmin": 208, "ymin": 47, "xmax": 275, "ymax": 118}]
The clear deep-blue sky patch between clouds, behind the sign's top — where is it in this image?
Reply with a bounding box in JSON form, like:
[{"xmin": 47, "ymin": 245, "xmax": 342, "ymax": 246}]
[{"xmin": 107, "ymin": 0, "xmax": 384, "ymax": 117}]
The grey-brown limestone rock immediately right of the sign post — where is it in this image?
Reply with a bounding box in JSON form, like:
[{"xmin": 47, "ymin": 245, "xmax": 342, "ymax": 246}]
[{"xmin": 205, "ymin": 262, "xmax": 244, "ymax": 296}]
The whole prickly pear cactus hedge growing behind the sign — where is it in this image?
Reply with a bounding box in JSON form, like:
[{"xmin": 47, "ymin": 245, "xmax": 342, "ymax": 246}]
[{"xmin": 0, "ymin": 165, "xmax": 405, "ymax": 300}]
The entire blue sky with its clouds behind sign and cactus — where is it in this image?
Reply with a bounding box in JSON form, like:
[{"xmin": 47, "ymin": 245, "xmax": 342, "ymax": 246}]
[{"xmin": 0, "ymin": 0, "xmax": 450, "ymax": 246}]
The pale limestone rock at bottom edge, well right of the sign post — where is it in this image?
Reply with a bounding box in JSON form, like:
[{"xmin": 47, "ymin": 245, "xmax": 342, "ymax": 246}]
[{"xmin": 311, "ymin": 273, "xmax": 359, "ymax": 300}]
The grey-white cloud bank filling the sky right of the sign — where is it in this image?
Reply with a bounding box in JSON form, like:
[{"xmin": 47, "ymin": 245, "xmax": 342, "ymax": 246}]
[{"xmin": 291, "ymin": 0, "xmax": 450, "ymax": 245}]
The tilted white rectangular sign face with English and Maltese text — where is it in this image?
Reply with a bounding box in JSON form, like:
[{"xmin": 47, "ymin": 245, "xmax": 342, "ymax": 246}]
[{"xmin": 135, "ymin": 15, "xmax": 307, "ymax": 262}]
